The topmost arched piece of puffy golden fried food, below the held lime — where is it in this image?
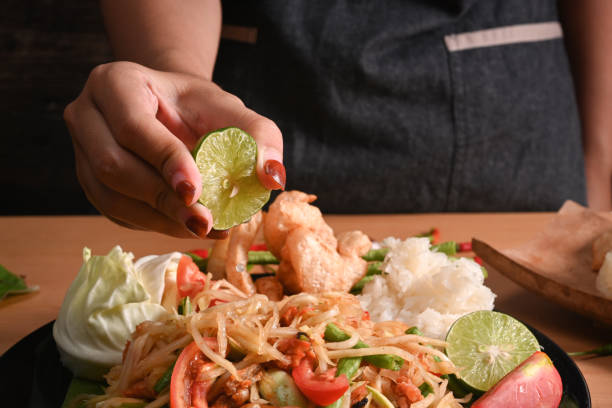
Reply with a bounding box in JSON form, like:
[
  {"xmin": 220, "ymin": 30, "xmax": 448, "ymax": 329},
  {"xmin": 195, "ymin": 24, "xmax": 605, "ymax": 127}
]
[{"xmin": 264, "ymin": 191, "xmax": 336, "ymax": 258}]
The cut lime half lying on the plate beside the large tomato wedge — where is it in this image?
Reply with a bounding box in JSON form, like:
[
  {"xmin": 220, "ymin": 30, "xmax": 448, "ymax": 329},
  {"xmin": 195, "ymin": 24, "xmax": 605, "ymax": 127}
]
[{"xmin": 446, "ymin": 310, "xmax": 540, "ymax": 392}]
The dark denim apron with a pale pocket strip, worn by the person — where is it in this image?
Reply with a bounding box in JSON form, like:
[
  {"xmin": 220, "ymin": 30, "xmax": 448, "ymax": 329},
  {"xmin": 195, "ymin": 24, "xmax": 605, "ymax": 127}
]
[{"xmin": 214, "ymin": 0, "xmax": 586, "ymax": 213}]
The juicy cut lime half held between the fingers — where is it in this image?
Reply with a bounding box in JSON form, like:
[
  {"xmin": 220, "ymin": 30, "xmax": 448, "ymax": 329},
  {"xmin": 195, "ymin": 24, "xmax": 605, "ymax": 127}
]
[{"xmin": 193, "ymin": 127, "xmax": 270, "ymax": 230}]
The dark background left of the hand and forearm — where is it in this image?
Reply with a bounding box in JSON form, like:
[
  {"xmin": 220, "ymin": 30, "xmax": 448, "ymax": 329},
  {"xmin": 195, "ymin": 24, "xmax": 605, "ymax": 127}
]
[{"xmin": 0, "ymin": 0, "xmax": 112, "ymax": 215}]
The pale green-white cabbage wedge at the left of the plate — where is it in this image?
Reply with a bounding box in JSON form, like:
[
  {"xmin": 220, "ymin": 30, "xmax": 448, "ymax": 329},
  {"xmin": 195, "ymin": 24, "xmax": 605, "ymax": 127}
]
[{"xmin": 53, "ymin": 246, "xmax": 181, "ymax": 380}]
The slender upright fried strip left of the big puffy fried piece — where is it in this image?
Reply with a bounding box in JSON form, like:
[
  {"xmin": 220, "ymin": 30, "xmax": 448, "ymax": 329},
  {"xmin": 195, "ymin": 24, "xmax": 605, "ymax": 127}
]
[{"xmin": 225, "ymin": 211, "xmax": 263, "ymax": 295}]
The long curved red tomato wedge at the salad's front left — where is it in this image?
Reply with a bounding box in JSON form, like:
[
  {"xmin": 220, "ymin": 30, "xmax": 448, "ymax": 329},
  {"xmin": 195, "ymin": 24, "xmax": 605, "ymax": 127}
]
[{"xmin": 170, "ymin": 337, "xmax": 217, "ymax": 408}]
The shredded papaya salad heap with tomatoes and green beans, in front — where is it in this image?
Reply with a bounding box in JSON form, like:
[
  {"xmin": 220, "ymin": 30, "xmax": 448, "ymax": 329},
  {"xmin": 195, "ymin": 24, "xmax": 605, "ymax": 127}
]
[{"xmin": 69, "ymin": 276, "xmax": 469, "ymax": 408}]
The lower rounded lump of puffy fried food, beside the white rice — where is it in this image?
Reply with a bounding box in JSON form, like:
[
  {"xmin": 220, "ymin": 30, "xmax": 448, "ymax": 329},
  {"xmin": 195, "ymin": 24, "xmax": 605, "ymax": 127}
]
[{"xmin": 276, "ymin": 227, "xmax": 370, "ymax": 293}]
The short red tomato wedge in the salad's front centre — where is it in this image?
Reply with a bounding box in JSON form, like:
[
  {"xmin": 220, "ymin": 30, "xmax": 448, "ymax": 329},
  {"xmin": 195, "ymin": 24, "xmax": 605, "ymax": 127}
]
[{"xmin": 292, "ymin": 358, "xmax": 349, "ymax": 408}]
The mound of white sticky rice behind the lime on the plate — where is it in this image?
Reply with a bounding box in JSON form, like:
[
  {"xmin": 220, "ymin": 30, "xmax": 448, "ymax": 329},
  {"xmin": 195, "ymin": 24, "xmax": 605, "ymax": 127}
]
[{"xmin": 359, "ymin": 238, "xmax": 495, "ymax": 339}]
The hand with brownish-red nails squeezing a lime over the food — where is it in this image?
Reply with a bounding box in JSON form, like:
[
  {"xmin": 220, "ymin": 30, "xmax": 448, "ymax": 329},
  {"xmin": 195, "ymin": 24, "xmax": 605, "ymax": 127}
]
[{"xmin": 64, "ymin": 62, "xmax": 285, "ymax": 238}]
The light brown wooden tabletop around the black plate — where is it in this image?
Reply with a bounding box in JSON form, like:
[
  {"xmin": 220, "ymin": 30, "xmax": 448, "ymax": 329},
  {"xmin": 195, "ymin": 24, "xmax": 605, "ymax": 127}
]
[{"xmin": 0, "ymin": 213, "xmax": 612, "ymax": 407}]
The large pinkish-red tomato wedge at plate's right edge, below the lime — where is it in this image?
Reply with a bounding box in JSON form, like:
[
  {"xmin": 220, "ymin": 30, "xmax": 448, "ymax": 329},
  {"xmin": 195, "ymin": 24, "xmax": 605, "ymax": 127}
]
[{"xmin": 472, "ymin": 351, "xmax": 563, "ymax": 408}]
